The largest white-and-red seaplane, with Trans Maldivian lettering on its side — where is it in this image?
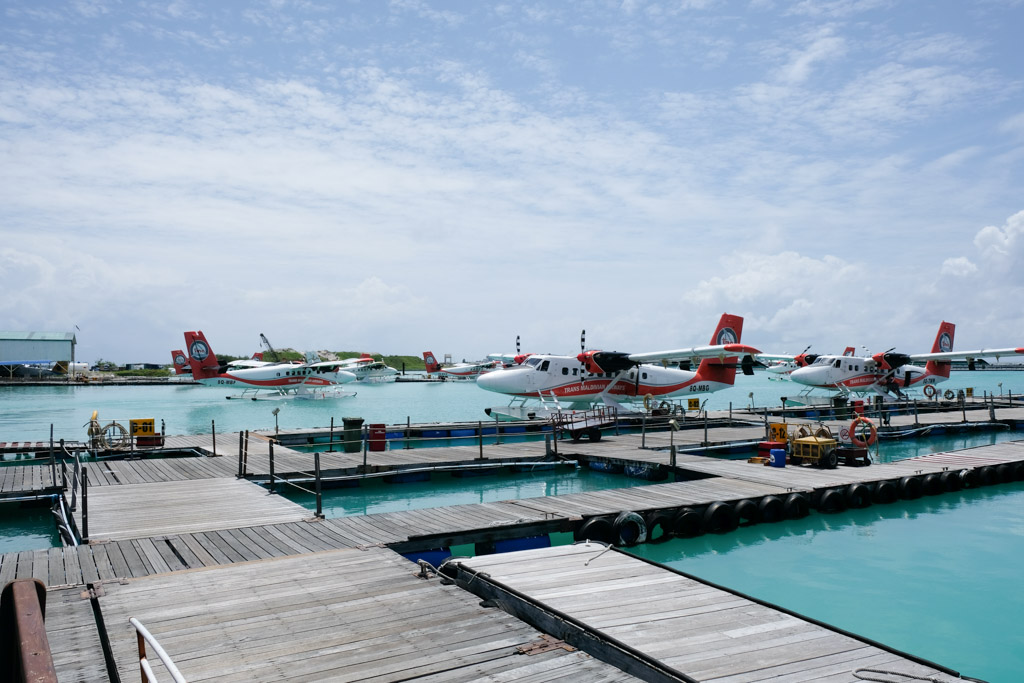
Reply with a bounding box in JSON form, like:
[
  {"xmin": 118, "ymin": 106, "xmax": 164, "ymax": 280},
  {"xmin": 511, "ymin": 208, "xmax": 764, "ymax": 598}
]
[{"xmin": 476, "ymin": 313, "xmax": 759, "ymax": 419}]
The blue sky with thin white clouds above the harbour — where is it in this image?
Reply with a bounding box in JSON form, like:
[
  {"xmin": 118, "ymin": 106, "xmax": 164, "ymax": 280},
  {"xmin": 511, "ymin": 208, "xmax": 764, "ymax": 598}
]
[{"xmin": 0, "ymin": 0, "xmax": 1024, "ymax": 362}]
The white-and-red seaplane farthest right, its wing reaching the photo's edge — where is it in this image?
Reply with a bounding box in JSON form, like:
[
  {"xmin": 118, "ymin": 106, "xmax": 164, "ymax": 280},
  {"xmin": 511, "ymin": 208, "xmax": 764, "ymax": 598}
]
[{"xmin": 774, "ymin": 322, "xmax": 1024, "ymax": 400}]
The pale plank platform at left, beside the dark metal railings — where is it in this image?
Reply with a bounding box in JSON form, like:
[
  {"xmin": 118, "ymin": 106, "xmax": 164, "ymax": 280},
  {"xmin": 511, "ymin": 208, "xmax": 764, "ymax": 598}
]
[{"xmin": 75, "ymin": 478, "xmax": 311, "ymax": 540}]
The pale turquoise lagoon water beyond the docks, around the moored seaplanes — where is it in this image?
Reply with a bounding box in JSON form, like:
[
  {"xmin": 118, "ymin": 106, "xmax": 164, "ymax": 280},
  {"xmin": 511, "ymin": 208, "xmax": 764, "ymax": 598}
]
[{"xmin": 0, "ymin": 371, "xmax": 1024, "ymax": 441}]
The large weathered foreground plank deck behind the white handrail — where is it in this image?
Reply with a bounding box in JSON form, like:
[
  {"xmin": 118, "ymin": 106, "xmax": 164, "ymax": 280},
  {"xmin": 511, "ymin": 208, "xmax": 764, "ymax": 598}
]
[{"xmin": 93, "ymin": 549, "xmax": 636, "ymax": 683}]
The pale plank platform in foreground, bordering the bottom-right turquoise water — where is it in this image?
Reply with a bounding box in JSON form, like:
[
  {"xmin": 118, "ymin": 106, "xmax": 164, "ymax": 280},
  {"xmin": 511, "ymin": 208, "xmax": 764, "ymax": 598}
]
[{"xmin": 456, "ymin": 544, "xmax": 970, "ymax": 683}]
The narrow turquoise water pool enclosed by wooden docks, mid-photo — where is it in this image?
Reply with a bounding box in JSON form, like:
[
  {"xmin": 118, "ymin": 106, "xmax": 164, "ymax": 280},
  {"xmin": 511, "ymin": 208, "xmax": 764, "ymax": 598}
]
[{"xmin": 279, "ymin": 467, "xmax": 651, "ymax": 517}]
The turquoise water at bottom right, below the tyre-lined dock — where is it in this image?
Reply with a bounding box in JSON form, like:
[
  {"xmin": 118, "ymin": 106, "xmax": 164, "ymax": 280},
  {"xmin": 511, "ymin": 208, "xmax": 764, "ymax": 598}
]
[{"xmin": 630, "ymin": 482, "xmax": 1024, "ymax": 683}]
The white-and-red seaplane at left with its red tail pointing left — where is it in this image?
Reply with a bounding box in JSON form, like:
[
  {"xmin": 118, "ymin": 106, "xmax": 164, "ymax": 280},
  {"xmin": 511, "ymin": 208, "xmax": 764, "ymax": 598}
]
[{"xmin": 184, "ymin": 331, "xmax": 355, "ymax": 400}]
